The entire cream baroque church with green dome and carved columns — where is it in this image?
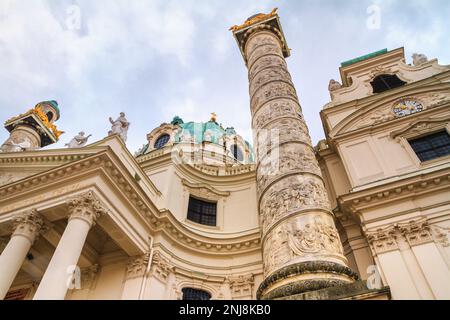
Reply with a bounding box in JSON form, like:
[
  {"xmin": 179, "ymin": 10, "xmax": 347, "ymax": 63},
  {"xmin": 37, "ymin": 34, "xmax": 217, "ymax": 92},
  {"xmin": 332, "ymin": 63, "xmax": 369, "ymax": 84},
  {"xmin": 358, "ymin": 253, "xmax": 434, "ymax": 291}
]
[{"xmin": 0, "ymin": 10, "xmax": 450, "ymax": 300}]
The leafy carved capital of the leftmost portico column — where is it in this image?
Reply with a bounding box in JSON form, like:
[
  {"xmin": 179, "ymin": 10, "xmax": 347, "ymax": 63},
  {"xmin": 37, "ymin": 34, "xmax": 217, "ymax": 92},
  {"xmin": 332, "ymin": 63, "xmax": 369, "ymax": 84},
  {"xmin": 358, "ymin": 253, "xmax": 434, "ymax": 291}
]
[{"xmin": 12, "ymin": 209, "xmax": 44, "ymax": 243}]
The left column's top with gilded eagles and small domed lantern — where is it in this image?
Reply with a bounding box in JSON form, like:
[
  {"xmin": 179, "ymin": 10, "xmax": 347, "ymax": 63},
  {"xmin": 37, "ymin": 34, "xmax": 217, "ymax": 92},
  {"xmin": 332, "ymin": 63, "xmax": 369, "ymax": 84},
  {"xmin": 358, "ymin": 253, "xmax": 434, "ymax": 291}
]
[{"xmin": 0, "ymin": 101, "xmax": 64, "ymax": 152}]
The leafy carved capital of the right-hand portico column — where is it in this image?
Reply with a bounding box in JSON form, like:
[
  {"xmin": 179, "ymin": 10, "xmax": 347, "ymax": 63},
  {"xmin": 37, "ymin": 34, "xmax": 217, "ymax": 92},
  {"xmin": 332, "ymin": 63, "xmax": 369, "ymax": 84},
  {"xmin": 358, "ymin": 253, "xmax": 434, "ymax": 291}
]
[{"xmin": 66, "ymin": 191, "xmax": 108, "ymax": 227}]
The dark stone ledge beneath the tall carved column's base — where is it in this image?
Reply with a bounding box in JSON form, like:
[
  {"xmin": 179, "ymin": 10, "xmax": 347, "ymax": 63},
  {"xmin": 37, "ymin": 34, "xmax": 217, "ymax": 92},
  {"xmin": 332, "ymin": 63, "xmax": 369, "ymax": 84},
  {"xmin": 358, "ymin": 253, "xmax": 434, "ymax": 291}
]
[{"xmin": 276, "ymin": 281, "xmax": 391, "ymax": 300}]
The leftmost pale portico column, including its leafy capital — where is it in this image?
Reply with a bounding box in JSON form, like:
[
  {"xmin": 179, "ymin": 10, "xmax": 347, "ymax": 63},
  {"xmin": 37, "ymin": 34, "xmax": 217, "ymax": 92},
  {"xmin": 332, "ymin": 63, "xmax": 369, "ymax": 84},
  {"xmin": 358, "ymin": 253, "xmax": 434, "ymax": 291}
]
[{"xmin": 0, "ymin": 209, "xmax": 43, "ymax": 300}]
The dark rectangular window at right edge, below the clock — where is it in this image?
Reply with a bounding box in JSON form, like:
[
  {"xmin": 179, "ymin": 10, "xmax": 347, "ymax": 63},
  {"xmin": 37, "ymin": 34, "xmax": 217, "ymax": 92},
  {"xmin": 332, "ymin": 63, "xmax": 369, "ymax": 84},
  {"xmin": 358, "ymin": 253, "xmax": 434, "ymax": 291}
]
[{"xmin": 409, "ymin": 131, "xmax": 450, "ymax": 162}]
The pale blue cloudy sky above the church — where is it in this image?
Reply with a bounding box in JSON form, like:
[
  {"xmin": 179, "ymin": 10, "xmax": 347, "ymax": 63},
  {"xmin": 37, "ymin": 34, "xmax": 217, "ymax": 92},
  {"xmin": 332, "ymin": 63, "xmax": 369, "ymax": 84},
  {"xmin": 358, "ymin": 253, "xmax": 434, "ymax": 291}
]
[{"xmin": 0, "ymin": 0, "xmax": 450, "ymax": 152}]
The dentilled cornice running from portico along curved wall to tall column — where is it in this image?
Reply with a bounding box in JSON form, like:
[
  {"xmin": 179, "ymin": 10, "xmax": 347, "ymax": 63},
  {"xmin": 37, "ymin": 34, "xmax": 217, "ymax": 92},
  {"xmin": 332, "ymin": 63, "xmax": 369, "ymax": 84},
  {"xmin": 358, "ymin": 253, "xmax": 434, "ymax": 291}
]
[{"xmin": 0, "ymin": 148, "xmax": 261, "ymax": 254}]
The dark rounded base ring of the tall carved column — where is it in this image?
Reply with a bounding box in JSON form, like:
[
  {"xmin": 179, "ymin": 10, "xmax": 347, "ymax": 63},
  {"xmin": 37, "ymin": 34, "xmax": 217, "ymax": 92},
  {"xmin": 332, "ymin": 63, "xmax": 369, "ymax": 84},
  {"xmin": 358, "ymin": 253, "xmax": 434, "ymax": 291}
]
[{"xmin": 257, "ymin": 261, "xmax": 359, "ymax": 300}]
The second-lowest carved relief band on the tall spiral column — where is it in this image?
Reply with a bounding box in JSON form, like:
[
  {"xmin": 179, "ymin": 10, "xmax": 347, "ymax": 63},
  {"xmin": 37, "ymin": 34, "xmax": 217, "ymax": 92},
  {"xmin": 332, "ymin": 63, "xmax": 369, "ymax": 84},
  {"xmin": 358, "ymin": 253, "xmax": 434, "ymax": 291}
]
[{"xmin": 260, "ymin": 175, "xmax": 330, "ymax": 234}]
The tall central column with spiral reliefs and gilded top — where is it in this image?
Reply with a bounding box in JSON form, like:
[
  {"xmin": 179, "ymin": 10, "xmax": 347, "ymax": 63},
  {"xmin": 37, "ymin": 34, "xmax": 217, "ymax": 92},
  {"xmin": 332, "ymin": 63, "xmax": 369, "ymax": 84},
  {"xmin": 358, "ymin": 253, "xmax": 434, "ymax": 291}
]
[{"xmin": 232, "ymin": 10, "xmax": 357, "ymax": 299}]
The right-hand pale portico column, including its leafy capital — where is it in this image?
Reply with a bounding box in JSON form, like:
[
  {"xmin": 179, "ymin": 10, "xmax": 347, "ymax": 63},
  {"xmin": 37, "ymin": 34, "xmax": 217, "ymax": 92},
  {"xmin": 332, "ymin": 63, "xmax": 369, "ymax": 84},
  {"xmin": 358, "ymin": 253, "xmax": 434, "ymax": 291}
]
[{"xmin": 33, "ymin": 192, "xmax": 106, "ymax": 300}]
